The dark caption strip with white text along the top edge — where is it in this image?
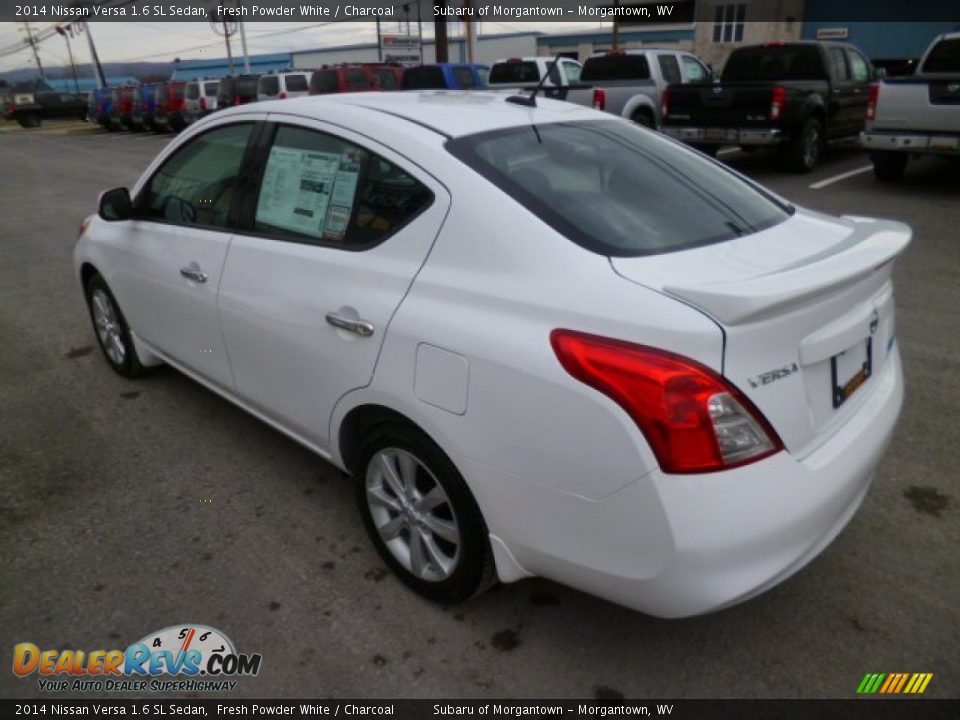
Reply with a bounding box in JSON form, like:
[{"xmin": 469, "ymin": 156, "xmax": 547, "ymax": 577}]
[{"xmin": 0, "ymin": 0, "xmax": 960, "ymax": 23}]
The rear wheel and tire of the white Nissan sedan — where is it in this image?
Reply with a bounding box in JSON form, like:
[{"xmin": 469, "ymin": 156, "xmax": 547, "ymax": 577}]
[{"xmin": 355, "ymin": 424, "xmax": 494, "ymax": 604}]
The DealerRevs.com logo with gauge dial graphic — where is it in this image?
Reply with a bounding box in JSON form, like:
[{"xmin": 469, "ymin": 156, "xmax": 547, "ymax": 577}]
[{"xmin": 13, "ymin": 624, "xmax": 262, "ymax": 692}]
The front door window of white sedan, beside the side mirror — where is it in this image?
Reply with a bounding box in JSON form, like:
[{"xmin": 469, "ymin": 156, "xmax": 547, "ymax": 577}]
[{"xmin": 137, "ymin": 123, "xmax": 253, "ymax": 228}]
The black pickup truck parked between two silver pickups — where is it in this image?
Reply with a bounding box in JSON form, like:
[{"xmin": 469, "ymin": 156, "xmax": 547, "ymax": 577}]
[{"xmin": 661, "ymin": 42, "xmax": 876, "ymax": 172}]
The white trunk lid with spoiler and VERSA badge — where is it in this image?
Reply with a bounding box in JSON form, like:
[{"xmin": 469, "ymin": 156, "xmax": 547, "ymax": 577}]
[{"xmin": 611, "ymin": 210, "xmax": 911, "ymax": 457}]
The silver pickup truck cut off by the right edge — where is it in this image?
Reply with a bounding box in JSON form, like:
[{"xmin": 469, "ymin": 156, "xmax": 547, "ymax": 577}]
[{"xmin": 860, "ymin": 32, "xmax": 960, "ymax": 181}]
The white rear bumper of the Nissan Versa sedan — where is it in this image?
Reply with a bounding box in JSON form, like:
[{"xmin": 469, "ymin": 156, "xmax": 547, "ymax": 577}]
[{"xmin": 490, "ymin": 348, "xmax": 903, "ymax": 618}]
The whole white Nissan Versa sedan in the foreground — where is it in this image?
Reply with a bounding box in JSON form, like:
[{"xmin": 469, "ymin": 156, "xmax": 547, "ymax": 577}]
[{"xmin": 75, "ymin": 92, "xmax": 910, "ymax": 617}]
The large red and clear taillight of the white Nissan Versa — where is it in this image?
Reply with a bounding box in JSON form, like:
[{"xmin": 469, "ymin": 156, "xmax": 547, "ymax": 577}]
[{"xmin": 550, "ymin": 330, "xmax": 783, "ymax": 473}]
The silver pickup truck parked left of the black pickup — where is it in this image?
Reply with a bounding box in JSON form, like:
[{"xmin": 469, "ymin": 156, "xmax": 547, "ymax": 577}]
[{"xmin": 566, "ymin": 48, "xmax": 713, "ymax": 128}]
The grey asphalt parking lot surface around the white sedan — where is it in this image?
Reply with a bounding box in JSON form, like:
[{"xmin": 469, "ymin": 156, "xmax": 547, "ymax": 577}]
[{"xmin": 0, "ymin": 124, "xmax": 960, "ymax": 698}]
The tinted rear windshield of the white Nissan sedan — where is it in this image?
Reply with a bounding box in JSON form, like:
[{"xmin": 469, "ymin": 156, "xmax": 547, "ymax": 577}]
[{"xmin": 447, "ymin": 120, "xmax": 792, "ymax": 257}]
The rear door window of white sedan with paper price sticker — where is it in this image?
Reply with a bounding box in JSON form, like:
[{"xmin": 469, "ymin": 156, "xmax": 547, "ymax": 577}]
[{"xmin": 254, "ymin": 126, "xmax": 433, "ymax": 248}]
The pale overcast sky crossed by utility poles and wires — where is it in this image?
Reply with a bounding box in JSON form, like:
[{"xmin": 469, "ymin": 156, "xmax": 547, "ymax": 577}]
[{"xmin": 0, "ymin": 22, "xmax": 600, "ymax": 72}]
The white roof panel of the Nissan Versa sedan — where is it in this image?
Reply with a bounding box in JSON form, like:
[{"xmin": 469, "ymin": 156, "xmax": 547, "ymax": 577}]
[{"xmin": 226, "ymin": 90, "xmax": 596, "ymax": 137}]
